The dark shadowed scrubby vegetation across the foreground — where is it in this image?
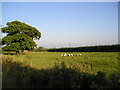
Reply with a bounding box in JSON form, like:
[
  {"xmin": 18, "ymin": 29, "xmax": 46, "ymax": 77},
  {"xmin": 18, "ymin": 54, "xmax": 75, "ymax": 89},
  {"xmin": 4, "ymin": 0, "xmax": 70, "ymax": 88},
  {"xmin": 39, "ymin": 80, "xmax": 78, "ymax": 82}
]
[{"xmin": 2, "ymin": 58, "xmax": 120, "ymax": 89}]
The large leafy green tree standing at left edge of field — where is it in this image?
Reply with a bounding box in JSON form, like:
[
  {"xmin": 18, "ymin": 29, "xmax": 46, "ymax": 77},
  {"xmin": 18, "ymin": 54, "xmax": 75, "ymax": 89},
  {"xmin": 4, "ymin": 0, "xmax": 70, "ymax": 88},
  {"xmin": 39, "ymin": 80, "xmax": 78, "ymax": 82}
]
[{"xmin": 2, "ymin": 20, "xmax": 41, "ymax": 54}]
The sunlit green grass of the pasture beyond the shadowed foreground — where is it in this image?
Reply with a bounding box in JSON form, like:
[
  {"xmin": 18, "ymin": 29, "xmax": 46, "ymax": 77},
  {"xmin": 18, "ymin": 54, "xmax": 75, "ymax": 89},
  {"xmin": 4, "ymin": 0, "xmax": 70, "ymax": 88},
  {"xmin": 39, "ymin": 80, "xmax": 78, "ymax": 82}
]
[{"xmin": 4, "ymin": 52, "xmax": 119, "ymax": 73}]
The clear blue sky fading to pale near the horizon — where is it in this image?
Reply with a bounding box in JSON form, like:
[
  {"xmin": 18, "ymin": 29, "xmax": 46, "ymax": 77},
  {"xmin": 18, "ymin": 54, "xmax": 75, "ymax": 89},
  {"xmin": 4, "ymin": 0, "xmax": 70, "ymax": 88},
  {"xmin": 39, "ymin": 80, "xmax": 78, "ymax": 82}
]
[{"xmin": 2, "ymin": 2, "xmax": 118, "ymax": 48}]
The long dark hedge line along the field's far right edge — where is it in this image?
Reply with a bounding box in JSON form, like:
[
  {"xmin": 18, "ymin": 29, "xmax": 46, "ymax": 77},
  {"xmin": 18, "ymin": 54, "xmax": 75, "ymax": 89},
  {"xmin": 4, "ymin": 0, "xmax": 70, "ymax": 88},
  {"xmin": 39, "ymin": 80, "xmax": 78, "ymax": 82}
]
[{"xmin": 48, "ymin": 44, "xmax": 120, "ymax": 52}]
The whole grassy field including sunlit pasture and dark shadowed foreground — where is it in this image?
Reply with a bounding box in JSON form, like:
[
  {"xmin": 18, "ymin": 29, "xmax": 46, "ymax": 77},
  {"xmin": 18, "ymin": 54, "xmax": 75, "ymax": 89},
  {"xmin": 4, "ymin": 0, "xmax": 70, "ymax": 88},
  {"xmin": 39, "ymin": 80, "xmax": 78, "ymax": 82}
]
[{"xmin": 2, "ymin": 52, "xmax": 120, "ymax": 89}]
